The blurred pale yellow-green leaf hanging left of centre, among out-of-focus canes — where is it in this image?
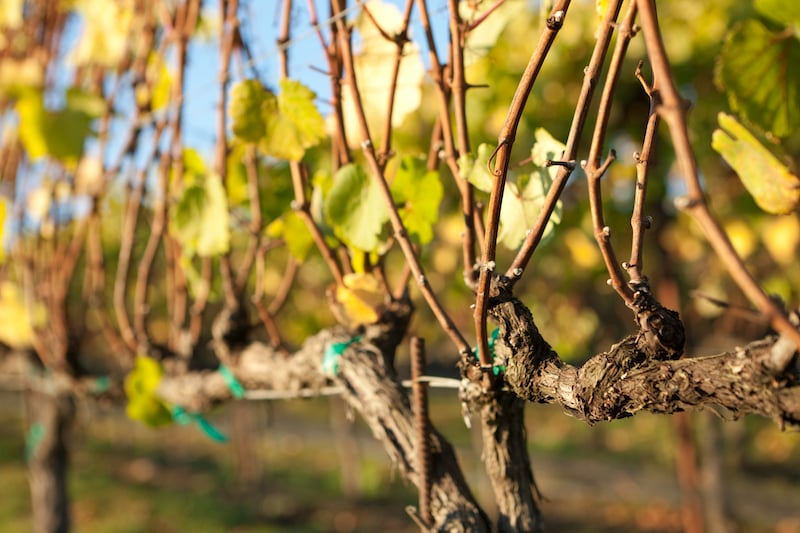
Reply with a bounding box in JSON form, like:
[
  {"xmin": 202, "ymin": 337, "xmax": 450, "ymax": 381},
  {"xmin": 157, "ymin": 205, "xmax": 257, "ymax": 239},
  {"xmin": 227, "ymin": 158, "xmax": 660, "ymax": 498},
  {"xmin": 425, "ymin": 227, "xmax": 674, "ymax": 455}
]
[{"xmin": 169, "ymin": 175, "xmax": 230, "ymax": 257}]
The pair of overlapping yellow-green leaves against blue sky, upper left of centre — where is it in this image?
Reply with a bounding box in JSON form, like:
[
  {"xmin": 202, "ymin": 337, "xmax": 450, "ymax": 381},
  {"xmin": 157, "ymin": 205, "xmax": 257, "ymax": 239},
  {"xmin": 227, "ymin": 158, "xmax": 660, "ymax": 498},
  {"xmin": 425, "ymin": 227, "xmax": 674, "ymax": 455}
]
[{"xmin": 228, "ymin": 79, "xmax": 325, "ymax": 161}]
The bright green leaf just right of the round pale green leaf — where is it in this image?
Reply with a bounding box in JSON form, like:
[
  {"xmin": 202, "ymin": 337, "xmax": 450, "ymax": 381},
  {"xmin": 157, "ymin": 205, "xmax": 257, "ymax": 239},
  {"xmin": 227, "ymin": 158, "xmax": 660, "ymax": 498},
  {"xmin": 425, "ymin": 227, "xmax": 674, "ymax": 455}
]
[{"xmin": 392, "ymin": 157, "xmax": 444, "ymax": 244}]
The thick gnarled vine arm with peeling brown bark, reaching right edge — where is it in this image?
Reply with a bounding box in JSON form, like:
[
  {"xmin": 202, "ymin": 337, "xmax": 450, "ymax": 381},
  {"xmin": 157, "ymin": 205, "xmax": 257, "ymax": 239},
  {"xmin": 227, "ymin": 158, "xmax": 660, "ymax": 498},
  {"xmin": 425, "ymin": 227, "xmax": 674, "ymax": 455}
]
[{"xmin": 492, "ymin": 286, "xmax": 800, "ymax": 427}]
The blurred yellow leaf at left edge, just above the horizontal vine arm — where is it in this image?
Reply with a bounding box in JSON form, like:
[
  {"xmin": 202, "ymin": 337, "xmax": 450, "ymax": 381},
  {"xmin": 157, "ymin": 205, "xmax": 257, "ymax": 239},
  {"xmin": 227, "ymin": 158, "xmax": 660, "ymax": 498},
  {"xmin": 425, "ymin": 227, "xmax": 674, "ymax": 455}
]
[{"xmin": 0, "ymin": 281, "xmax": 47, "ymax": 349}]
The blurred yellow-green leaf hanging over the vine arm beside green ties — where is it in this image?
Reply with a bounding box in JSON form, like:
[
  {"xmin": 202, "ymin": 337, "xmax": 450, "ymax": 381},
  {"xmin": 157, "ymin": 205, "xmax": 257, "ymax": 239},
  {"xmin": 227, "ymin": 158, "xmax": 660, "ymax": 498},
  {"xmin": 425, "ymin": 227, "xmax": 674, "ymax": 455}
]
[{"xmin": 124, "ymin": 355, "xmax": 172, "ymax": 427}]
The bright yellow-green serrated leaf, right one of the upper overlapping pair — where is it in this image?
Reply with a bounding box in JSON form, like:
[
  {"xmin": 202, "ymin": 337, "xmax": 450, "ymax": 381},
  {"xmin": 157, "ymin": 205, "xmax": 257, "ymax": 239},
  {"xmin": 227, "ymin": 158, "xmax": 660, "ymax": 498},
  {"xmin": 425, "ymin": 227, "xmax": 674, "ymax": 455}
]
[{"xmin": 258, "ymin": 79, "xmax": 325, "ymax": 161}]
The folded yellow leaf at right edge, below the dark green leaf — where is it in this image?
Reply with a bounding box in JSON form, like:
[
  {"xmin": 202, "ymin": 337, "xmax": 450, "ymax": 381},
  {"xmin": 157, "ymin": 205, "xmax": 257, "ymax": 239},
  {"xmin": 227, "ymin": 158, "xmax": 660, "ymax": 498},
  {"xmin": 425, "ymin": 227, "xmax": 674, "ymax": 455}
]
[{"xmin": 711, "ymin": 113, "xmax": 800, "ymax": 215}]
